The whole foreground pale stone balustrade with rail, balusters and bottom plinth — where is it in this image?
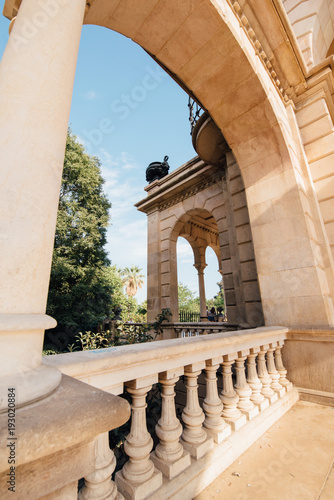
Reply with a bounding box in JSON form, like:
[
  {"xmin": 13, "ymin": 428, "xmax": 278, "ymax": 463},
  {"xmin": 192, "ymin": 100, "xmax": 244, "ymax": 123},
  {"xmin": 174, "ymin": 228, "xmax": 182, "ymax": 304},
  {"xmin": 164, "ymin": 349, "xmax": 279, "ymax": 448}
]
[{"xmin": 44, "ymin": 327, "xmax": 298, "ymax": 500}]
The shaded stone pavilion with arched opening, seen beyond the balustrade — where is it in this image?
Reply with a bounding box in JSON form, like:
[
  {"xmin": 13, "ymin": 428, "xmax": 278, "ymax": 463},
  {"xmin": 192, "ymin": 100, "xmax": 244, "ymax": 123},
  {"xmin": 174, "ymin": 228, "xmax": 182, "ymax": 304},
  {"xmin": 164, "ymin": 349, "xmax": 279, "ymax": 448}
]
[{"xmin": 137, "ymin": 156, "xmax": 263, "ymax": 327}]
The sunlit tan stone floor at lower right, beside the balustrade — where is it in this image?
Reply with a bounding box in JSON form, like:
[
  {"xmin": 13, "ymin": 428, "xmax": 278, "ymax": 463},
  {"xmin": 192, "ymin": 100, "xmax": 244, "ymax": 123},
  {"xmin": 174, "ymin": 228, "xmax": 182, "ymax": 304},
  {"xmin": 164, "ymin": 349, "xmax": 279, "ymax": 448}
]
[{"xmin": 194, "ymin": 401, "xmax": 334, "ymax": 500}]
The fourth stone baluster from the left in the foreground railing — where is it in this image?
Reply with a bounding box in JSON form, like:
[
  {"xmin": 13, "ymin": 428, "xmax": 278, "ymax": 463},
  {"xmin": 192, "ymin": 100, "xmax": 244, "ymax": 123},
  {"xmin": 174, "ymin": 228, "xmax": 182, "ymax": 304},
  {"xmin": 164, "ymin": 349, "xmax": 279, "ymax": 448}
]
[{"xmin": 181, "ymin": 361, "xmax": 213, "ymax": 460}]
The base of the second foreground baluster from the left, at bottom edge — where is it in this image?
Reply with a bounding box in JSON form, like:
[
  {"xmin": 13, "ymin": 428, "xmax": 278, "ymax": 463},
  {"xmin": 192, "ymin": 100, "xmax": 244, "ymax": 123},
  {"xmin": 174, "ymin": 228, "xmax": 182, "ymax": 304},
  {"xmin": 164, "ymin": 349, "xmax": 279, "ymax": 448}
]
[{"xmin": 115, "ymin": 468, "xmax": 162, "ymax": 500}]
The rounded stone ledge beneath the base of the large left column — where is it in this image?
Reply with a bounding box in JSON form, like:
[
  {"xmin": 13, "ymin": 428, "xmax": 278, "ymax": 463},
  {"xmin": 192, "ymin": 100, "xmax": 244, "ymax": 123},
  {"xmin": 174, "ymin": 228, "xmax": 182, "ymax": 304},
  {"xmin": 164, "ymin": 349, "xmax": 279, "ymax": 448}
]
[{"xmin": 0, "ymin": 375, "xmax": 130, "ymax": 472}]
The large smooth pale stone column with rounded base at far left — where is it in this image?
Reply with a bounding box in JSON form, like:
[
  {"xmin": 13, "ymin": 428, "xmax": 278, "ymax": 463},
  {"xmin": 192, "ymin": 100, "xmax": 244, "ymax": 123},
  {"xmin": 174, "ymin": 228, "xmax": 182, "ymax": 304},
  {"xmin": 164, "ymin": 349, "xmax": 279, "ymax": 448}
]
[{"xmin": 0, "ymin": 0, "xmax": 86, "ymax": 405}]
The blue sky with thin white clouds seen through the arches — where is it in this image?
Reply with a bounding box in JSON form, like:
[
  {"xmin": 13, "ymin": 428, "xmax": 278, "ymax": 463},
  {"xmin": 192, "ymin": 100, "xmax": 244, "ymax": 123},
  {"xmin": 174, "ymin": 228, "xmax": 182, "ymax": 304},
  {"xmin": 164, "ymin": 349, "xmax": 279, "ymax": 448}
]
[{"xmin": 0, "ymin": 16, "xmax": 224, "ymax": 302}]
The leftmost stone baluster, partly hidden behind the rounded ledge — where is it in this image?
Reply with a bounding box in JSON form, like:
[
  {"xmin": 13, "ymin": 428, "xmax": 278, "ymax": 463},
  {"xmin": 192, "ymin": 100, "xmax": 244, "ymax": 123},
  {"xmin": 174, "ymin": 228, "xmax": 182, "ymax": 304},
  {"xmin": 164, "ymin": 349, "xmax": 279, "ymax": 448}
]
[{"xmin": 78, "ymin": 432, "xmax": 124, "ymax": 500}]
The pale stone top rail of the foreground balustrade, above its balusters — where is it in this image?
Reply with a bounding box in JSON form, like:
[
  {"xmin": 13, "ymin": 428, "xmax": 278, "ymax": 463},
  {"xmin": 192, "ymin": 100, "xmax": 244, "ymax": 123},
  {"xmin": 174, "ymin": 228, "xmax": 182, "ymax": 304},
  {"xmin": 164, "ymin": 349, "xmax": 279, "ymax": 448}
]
[{"xmin": 43, "ymin": 327, "xmax": 288, "ymax": 394}]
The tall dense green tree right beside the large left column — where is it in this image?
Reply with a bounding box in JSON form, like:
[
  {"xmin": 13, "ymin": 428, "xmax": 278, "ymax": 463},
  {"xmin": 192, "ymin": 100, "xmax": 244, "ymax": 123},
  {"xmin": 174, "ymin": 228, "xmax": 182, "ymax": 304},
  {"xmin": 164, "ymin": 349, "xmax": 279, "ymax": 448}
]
[{"xmin": 47, "ymin": 131, "xmax": 113, "ymax": 346}]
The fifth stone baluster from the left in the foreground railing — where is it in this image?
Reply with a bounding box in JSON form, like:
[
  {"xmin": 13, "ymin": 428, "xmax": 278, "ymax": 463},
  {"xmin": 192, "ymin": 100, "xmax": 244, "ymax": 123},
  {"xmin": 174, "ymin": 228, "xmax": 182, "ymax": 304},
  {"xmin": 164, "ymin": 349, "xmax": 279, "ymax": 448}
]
[{"xmin": 203, "ymin": 356, "xmax": 231, "ymax": 443}]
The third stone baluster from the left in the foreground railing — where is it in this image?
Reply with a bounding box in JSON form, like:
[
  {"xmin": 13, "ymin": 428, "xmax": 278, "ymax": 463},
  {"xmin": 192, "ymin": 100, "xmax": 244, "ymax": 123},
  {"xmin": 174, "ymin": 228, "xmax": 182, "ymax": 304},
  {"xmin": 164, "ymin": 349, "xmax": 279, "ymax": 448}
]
[{"xmin": 151, "ymin": 368, "xmax": 191, "ymax": 479}]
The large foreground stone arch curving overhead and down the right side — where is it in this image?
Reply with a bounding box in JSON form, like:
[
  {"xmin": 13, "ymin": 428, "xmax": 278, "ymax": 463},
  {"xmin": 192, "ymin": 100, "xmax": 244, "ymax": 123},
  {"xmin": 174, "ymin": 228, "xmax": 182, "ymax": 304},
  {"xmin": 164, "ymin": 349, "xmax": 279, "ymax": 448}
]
[{"xmin": 85, "ymin": 0, "xmax": 334, "ymax": 325}]
